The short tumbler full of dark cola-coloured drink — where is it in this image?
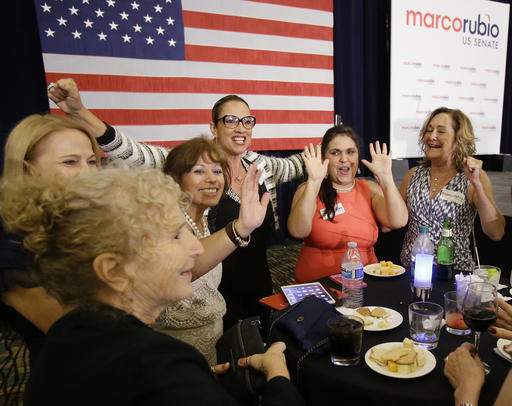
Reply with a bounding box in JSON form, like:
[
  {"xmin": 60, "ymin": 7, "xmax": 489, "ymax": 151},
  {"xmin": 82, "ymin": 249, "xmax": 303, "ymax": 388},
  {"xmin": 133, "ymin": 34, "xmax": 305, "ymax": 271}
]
[{"xmin": 327, "ymin": 315, "xmax": 364, "ymax": 366}]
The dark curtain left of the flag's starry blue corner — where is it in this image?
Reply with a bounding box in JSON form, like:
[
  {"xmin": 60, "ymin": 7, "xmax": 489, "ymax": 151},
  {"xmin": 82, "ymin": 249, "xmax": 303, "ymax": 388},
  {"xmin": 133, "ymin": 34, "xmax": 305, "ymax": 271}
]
[{"xmin": 0, "ymin": 0, "xmax": 49, "ymax": 172}]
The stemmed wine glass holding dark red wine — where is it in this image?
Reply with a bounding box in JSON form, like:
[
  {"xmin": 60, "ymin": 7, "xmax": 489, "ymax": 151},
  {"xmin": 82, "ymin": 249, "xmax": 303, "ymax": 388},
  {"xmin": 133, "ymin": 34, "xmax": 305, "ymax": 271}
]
[{"xmin": 462, "ymin": 282, "xmax": 498, "ymax": 374}]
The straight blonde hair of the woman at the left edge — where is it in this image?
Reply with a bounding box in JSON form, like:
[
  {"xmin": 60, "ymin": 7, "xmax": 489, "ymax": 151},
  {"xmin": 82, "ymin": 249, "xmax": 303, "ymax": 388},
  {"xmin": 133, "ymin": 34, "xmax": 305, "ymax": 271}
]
[{"xmin": 3, "ymin": 114, "xmax": 101, "ymax": 180}]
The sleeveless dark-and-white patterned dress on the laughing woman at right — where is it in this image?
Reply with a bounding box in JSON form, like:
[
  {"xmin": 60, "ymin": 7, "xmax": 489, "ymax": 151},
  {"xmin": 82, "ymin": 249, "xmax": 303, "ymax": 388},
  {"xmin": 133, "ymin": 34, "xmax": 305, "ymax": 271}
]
[{"xmin": 400, "ymin": 167, "xmax": 476, "ymax": 272}]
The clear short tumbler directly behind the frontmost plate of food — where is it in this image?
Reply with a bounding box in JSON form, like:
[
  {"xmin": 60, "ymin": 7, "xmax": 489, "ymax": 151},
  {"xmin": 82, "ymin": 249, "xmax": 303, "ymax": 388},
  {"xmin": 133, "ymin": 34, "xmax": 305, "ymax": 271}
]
[{"xmin": 409, "ymin": 302, "xmax": 443, "ymax": 350}]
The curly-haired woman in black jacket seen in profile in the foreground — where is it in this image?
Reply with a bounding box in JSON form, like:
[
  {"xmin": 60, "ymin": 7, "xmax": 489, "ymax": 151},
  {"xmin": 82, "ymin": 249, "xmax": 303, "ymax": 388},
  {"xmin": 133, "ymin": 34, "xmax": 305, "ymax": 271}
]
[{"xmin": 1, "ymin": 169, "xmax": 302, "ymax": 405}]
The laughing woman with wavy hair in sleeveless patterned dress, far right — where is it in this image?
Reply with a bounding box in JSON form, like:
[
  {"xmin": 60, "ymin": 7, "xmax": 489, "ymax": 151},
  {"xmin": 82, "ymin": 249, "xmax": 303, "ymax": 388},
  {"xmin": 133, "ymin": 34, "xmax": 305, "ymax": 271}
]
[{"xmin": 400, "ymin": 107, "xmax": 505, "ymax": 271}]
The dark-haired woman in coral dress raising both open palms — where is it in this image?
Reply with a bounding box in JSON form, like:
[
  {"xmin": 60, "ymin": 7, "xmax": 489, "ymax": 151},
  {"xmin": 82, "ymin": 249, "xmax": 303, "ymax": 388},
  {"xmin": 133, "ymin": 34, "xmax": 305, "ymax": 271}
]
[{"xmin": 288, "ymin": 125, "xmax": 407, "ymax": 283}]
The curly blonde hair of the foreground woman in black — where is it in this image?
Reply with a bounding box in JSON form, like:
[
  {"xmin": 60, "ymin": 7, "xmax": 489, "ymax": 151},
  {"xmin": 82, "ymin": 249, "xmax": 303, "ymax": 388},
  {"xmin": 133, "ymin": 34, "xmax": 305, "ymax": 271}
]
[{"xmin": 0, "ymin": 169, "xmax": 187, "ymax": 305}]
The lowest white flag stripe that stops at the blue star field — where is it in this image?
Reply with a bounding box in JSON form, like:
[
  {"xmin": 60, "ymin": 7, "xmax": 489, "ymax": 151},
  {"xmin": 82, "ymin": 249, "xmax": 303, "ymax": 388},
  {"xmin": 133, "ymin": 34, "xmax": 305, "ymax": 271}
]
[{"xmin": 185, "ymin": 28, "xmax": 333, "ymax": 56}]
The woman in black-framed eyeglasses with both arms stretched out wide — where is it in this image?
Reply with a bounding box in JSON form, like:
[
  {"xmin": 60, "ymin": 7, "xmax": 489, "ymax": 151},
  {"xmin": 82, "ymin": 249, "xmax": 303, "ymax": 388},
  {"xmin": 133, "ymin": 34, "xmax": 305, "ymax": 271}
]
[{"xmin": 48, "ymin": 79, "xmax": 303, "ymax": 328}]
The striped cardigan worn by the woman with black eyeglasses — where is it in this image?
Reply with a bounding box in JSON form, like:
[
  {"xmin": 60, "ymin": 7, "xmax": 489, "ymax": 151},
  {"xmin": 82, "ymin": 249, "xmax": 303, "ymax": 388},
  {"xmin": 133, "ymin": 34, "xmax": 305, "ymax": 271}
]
[{"xmin": 97, "ymin": 126, "xmax": 304, "ymax": 230}]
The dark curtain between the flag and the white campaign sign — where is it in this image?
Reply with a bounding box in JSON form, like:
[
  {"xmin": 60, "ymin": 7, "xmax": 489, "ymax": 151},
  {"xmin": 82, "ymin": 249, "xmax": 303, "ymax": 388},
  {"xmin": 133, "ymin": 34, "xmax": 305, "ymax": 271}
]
[{"xmin": 334, "ymin": 0, "xmax": 390, "ymax": 174}]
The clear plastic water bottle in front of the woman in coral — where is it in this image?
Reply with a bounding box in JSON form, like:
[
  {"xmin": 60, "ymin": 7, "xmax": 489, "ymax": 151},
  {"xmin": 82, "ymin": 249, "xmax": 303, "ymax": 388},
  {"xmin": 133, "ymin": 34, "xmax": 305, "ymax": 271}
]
[{"xmin": 341, "ymin": 241, "xmax": 364, "ymax": 309}]
